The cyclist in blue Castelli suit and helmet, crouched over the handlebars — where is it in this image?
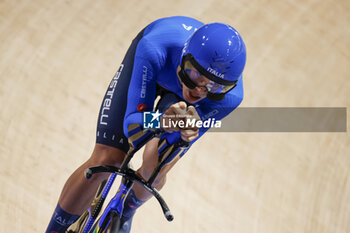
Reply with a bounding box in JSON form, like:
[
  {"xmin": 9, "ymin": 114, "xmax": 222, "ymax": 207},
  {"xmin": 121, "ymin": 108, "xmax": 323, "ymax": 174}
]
[{"xmin": 46, "ymin": 16, "xmax": 246, "ymax": 233}]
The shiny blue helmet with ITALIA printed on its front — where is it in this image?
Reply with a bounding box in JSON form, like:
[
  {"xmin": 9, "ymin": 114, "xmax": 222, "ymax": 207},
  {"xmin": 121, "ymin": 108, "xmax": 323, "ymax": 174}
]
[{"xmin": 179, "ymin": 23, "xmax": 246, "ymax": 101}]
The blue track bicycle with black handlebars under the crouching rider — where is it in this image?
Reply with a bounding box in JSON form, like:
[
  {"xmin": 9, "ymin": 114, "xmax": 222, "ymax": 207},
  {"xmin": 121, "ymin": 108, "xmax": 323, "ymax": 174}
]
[{"xmin": 66, "ymin": 124, "xmax": 190, "ymax": 233}]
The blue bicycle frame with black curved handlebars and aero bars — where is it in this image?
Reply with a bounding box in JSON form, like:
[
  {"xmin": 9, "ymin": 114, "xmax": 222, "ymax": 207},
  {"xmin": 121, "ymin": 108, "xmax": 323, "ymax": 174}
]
[{"xmin": 68, "ymin": 127, "xmax": 189, "ymax": 233}]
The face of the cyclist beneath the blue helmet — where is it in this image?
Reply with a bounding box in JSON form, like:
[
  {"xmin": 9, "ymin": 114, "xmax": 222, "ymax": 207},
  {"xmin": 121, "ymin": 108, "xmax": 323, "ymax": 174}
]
[{"xmin": 178, "ymin": 66, "xmax": 210, "ymax": 103}]
